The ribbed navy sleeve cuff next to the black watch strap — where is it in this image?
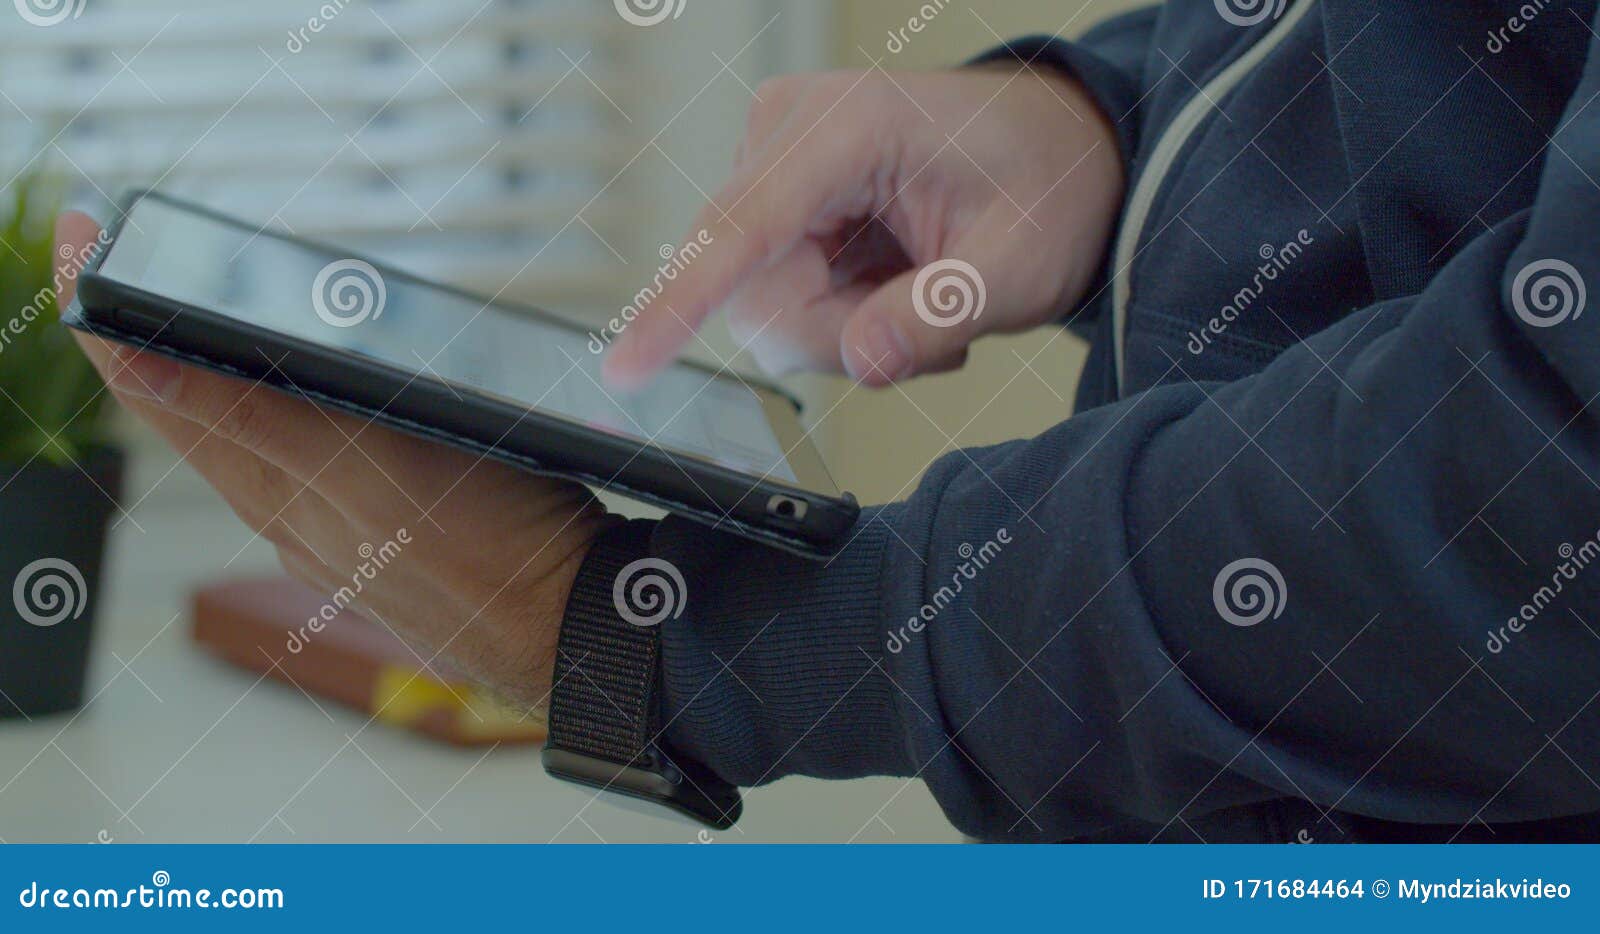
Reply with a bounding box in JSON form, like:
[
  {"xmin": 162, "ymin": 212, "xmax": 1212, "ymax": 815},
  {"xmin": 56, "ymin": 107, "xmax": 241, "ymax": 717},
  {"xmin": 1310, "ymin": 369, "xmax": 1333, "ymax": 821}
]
[{"xmin": 651, "ymin": 507, "xmax": 910, "ymax": 785}]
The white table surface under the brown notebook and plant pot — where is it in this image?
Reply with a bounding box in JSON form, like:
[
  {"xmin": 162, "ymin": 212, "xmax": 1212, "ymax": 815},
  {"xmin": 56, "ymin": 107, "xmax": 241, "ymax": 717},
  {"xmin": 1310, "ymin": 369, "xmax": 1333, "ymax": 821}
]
[{"xmin": 0, "ymin": 437, "xmax": 960, "ymax": 843}]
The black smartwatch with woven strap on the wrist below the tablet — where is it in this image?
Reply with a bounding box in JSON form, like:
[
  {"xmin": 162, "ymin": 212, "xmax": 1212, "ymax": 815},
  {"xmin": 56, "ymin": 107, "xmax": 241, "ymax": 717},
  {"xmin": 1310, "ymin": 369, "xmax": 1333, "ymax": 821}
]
[{"xmin": 541, "ymin": 521, "xmax": 744, "ymax": 830}]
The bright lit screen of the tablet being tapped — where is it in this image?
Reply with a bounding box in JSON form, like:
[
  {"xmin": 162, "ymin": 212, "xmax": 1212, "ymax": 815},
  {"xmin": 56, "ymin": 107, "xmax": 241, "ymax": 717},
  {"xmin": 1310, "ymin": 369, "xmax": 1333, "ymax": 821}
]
[{"xmin": 101, "ymin": 198, "xmax": 795, "ymax": 483}]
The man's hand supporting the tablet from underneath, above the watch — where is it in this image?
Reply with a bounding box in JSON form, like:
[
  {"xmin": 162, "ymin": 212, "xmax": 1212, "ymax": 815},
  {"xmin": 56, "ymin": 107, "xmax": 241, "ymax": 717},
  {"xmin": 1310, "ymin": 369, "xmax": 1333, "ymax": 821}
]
[{"xmin": 56, "ymin": 214, "xmax": 613, "ymax": 705}]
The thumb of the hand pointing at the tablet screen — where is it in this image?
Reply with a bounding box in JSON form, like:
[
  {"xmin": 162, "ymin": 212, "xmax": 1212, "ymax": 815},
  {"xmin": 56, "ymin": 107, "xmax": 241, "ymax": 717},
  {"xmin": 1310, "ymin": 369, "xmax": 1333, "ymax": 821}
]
[{"xmin": 840, "ymin": 257, "xmax": 990, "ymax": 385}]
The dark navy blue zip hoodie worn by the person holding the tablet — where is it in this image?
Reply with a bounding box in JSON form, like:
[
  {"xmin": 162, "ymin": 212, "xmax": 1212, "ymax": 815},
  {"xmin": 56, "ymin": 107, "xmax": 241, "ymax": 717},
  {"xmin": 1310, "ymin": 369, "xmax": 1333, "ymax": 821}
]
[{"xmin": 592, "ymin": 0, "xmax": 1600, "ymax": 841}]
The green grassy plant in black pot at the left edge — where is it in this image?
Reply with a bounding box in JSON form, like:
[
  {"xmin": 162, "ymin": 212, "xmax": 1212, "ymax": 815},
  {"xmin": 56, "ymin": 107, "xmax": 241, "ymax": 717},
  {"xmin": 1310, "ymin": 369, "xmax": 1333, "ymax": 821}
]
[{"xmin": 0, "ymin": 170, "xmax": 123, "ymax": 718}]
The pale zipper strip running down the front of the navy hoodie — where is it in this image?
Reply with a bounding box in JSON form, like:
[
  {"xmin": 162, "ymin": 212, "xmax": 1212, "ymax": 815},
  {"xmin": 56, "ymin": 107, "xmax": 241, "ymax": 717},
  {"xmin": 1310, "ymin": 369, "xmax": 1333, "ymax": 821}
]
[{"xmin": 1112, "ymin": 0, "xmax": 1317, "ymax": 397}]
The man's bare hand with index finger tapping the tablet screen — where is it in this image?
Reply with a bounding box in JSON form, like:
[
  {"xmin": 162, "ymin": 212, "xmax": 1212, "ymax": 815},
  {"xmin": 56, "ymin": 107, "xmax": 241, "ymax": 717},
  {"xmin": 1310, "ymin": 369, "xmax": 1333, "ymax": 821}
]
[{"xmin": 606, "ymin": 66, "xmax": 1123, "ymax": 387}]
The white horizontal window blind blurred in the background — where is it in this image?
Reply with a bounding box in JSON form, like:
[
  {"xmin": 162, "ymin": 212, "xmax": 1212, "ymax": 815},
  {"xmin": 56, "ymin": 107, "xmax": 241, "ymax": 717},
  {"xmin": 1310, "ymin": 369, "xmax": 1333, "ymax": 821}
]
[{"xmin": 0, "ymin": 0, "xmax": 637, "ymax": 301}]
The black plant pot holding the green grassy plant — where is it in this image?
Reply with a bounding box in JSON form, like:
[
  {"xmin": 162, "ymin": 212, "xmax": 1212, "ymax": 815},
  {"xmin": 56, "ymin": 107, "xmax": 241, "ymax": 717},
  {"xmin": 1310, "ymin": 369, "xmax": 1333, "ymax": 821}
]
[{"xmin": 0, "ymin": 448, "xmax": 123, "ymax": 718}]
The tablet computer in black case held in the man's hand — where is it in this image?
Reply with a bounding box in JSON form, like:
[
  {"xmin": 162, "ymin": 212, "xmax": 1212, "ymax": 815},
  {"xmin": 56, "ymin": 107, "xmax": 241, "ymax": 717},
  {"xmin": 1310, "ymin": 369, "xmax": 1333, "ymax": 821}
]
[{"xmin": 64, "ymin": 192, "xmax": 859, "ymax": 557}]
